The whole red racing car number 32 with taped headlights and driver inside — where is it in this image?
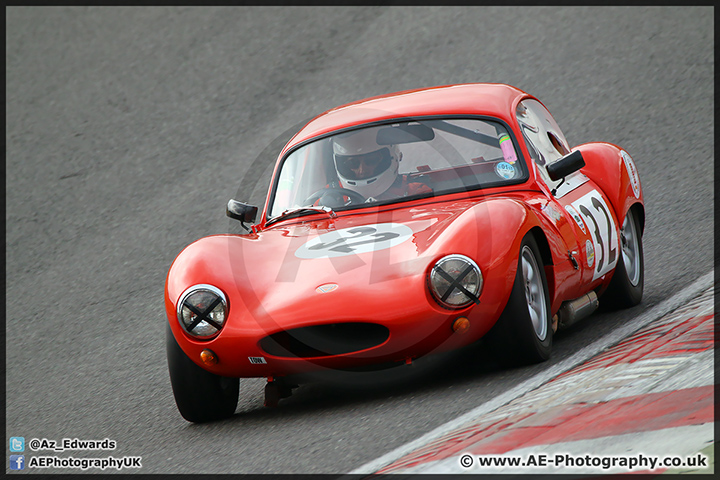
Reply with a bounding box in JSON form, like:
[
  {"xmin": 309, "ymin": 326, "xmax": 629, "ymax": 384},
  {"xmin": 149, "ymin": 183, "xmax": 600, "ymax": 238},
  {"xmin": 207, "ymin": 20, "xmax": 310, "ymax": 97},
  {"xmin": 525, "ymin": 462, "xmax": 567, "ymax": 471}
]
[{"xmin": 165, "ymin": 84, "xmax": 645, "ymax": 422}]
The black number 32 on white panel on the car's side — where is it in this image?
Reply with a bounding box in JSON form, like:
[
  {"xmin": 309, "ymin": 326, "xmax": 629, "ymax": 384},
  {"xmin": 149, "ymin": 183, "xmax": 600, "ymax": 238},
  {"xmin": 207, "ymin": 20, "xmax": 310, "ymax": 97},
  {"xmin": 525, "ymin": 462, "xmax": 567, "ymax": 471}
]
[{"xmin": 572, "ymin": 190, "xmax": 618, "ymax": 280}]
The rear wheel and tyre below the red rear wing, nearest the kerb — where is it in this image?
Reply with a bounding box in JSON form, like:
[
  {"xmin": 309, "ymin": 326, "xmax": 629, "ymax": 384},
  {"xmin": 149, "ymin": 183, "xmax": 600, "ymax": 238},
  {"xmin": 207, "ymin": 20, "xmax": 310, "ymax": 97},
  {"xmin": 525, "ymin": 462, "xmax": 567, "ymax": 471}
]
[{"xmin": 600, "ymin": 209, "xmax": 645, "ymax": 309}]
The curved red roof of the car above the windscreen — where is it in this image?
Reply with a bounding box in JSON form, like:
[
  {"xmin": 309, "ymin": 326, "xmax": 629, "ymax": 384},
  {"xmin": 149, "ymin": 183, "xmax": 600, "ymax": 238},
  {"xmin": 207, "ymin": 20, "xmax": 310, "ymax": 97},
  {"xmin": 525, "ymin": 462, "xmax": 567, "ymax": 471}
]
[{"xmin": 282, "ymin": 83, "xmax": 530, "ymax": 155}]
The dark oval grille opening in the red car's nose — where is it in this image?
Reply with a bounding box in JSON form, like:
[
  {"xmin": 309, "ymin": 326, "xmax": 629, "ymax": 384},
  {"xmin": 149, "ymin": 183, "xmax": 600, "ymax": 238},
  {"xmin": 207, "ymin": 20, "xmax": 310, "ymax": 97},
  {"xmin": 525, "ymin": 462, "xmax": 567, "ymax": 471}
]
[{"xmin": 260, "ymin": 322, "xmax": 390, "ymax": 358}]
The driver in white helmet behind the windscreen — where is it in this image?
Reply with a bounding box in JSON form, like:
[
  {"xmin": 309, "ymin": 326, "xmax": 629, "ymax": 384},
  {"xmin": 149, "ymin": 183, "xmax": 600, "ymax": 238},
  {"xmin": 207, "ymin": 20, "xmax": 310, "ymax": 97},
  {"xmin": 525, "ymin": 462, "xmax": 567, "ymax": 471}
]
[{"xmin": 333, "ymin": 128, "xmax": 432, "ymax": 201}]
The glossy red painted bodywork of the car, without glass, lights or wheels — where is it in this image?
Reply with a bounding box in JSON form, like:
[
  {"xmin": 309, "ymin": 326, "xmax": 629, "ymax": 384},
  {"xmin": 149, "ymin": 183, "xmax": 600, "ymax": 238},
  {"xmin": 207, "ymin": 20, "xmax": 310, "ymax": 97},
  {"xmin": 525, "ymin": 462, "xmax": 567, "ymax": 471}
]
[{"xmin": 165, "ymin": 84, "xmax": 643, "ymax": 377}]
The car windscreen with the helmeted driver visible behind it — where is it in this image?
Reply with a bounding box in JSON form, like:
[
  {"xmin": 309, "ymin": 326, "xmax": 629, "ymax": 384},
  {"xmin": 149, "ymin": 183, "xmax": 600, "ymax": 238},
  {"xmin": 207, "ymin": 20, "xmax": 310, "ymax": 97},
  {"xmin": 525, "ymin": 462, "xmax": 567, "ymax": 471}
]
[{"xmin": 269, "ymin": 118, "xmax": 528, "ymax": 217}]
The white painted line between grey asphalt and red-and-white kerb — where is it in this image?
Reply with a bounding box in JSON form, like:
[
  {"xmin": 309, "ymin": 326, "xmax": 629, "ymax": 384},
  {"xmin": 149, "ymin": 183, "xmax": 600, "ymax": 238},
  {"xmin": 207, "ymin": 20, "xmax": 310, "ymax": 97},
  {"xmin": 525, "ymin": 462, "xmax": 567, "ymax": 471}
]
[{"xmin": 349, "ymin": 271, "xmax": 714, "ymax": 475}]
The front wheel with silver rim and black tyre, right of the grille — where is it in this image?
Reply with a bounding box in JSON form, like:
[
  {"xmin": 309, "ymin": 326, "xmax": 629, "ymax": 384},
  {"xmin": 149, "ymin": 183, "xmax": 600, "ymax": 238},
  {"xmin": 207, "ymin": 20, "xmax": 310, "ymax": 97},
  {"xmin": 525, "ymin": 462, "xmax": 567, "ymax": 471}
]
[{"xmin": 486, "ymin": 234, "xmax": 553, "ymax": 365}]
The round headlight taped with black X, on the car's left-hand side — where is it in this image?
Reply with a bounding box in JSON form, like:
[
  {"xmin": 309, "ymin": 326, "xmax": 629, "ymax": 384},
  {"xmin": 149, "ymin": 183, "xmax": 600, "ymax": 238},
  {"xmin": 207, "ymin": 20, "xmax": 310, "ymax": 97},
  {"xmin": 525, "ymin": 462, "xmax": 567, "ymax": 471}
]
[{"xmin": 177, "ymin": 285, "xmax": 227, "ymax": 339}]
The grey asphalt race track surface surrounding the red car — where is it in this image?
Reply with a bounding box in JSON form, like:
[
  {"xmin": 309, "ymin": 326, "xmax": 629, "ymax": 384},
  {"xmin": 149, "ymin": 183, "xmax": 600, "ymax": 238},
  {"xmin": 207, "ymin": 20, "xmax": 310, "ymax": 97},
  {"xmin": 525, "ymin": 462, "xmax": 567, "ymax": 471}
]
[{"xmin": 5, "ymin": 6, "xmax": 714, "ymax": 473}]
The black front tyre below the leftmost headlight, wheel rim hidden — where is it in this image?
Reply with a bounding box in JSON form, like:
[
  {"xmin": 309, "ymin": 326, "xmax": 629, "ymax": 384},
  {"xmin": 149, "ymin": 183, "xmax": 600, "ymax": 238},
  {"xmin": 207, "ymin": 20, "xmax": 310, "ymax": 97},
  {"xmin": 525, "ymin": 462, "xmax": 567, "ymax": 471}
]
[{"xmin": 166, "ymin": 326, "xmax": 240, "ymax": 423}]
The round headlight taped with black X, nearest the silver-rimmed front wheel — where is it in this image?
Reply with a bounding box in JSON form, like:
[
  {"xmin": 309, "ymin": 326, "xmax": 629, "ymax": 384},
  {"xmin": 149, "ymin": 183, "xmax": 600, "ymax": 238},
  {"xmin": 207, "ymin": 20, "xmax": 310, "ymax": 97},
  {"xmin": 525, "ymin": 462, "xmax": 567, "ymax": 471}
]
[{"xmin": 429, "ymin": 255, "xmax": 483, "ymax": 308}]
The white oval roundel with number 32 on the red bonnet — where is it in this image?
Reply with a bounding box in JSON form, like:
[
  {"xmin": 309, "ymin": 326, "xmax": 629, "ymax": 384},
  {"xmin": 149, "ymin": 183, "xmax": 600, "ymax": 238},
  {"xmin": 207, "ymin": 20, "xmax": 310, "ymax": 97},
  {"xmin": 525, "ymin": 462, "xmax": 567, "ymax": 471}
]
[{"xmin": 295, "ymin": 223, "xmax": 413, "ymax": 258}]
